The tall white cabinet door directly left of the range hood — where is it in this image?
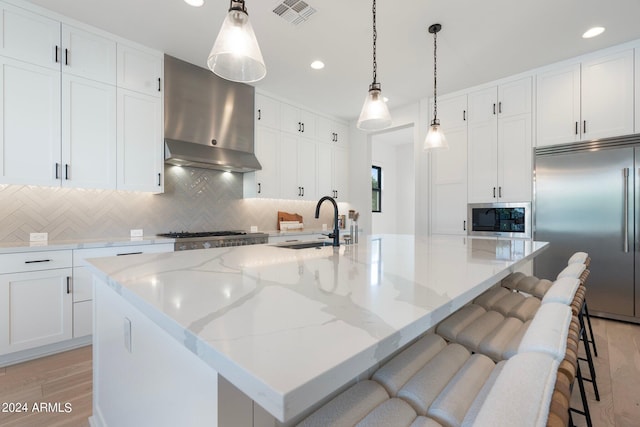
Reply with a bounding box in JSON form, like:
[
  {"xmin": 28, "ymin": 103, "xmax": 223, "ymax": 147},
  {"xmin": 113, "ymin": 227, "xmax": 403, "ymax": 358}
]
[{"xmin": 117, "ymin": 89, "xmax": 164, "ymax": 193}]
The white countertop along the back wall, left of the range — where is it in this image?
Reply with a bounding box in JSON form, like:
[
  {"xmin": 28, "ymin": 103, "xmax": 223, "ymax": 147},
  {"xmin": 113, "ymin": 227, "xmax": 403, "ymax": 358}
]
[{"xmin": 0, "ymin": 236, "xmax": 175, "ymax": 255}]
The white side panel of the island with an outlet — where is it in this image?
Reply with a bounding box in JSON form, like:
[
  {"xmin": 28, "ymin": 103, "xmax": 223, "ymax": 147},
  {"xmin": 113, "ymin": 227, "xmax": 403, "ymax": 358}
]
[{"xmin": 91, "ymin": 277, "xmax": 219, "ymax": 427}]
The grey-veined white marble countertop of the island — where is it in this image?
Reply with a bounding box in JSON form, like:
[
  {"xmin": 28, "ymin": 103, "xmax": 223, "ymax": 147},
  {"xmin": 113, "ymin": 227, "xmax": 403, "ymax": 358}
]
[{"xmin": 86, "ymin": 235, "xmax": 547, "ymax": 422}]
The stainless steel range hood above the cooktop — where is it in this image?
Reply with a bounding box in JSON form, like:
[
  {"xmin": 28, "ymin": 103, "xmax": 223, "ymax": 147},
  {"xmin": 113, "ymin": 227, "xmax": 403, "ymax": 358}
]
[{"xmin": 164, "ymin": 55, "xmax": 262, "ymax": 172}]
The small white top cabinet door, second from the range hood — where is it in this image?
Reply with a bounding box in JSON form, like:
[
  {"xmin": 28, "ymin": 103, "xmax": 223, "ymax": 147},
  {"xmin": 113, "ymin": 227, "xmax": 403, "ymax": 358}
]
[{"xmin": 62, "ymin": 24, "xmax": 116, "ymax": 85}]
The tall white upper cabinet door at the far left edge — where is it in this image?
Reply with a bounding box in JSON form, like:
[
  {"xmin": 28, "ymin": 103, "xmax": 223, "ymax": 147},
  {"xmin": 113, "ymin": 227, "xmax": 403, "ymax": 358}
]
[{"xmin": 0, "ymin": 57, "xmax": 61, "ymax": 186}]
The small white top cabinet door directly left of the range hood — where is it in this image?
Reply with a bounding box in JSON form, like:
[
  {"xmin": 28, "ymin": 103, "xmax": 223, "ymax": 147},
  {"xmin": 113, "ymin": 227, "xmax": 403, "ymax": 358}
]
[{"xmin": 117, "ymin": 43, "xmax": 164, "ymax": 97}]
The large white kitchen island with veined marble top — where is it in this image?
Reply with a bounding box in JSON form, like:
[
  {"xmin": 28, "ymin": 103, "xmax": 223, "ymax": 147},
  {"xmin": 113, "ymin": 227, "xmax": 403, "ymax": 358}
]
[{"xmin": 84, "ymin": 235, "xmax": 547, "ymax": 427}]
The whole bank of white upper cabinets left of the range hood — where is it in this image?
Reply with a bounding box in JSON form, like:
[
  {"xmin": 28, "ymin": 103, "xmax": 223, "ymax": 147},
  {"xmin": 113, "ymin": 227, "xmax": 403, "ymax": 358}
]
[{"xmin": 0, "ymin": 3, "xmax": 163, "ymax": 192}]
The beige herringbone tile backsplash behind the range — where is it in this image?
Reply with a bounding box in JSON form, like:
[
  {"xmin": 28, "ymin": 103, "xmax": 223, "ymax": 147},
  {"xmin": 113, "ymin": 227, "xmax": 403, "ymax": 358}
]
[{"xmin": 0, "ymin": 167, "xmax": 348, "ymax": 242}]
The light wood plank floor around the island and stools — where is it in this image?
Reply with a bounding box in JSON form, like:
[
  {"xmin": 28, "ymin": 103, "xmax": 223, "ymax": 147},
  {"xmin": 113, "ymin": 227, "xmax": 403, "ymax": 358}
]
[{"xmin": 0, "ymin": 318, "xmax": 640, "ymax": 427}]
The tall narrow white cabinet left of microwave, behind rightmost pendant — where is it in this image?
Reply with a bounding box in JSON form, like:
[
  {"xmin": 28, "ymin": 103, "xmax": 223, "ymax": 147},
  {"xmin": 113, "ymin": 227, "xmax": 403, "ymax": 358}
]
[{"xmin": 429, "ymin": 95, "xmax": 467, "ymax": 235}]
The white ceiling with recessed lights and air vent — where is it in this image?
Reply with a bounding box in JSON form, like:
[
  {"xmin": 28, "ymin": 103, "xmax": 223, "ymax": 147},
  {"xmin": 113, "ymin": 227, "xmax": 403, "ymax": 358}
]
[{"xmin": 25, "ymin": 0, "xmax": 640, "ymax": 120}]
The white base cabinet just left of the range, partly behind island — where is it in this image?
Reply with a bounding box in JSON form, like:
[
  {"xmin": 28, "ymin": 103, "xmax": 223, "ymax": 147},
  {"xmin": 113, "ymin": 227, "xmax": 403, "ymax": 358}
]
[{"xmin": 71, "ymin": 243, "xmax": 173, "ymax": 338}]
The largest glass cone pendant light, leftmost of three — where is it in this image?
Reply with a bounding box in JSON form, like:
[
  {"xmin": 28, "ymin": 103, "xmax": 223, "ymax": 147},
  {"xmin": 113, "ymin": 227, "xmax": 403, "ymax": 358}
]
[{"xmin": 207, "ymin": 0, "xmax": 267, "ymax": 83}]
